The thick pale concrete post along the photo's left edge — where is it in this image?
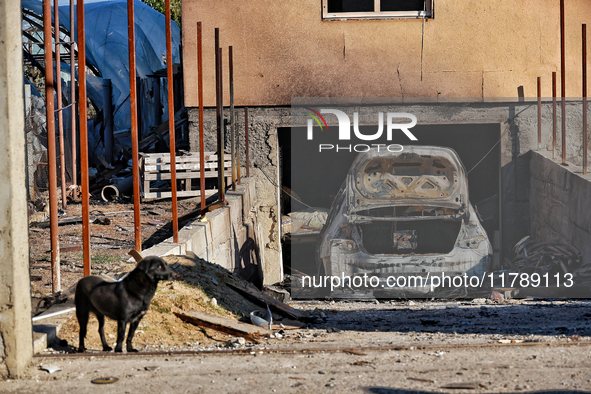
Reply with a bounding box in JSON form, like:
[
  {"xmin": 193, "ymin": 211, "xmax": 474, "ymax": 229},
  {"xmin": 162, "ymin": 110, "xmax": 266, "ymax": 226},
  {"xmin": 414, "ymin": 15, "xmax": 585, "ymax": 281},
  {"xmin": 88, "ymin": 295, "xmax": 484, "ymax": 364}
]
[{"xmin": 0, "ymin": 0, "xmax": 33, "ymax": 376}]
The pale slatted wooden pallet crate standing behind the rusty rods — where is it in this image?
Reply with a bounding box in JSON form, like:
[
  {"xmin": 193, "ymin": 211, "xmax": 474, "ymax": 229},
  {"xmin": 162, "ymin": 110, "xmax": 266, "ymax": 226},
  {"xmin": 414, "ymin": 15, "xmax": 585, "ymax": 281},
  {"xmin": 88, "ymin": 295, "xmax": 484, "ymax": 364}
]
[{"xmin": 140, "ymin": 152, "xmax": 232, "ymax": 199}]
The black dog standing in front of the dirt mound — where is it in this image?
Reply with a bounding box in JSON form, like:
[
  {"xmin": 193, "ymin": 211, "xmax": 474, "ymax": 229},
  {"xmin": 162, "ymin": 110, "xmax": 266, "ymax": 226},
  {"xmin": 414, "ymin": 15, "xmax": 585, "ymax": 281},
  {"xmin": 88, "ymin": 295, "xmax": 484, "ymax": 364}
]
[{"xmin": 76, "ymin": 256, "xmax": 173, "ymax": 353}]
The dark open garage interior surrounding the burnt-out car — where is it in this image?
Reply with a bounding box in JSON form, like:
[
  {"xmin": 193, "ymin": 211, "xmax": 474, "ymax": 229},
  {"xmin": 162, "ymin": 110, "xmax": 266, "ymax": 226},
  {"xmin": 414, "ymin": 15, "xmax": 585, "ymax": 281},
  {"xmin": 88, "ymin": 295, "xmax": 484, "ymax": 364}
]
[{"xmin": 278, "ymin": 123, "xmax": 501, "ymax": 275}]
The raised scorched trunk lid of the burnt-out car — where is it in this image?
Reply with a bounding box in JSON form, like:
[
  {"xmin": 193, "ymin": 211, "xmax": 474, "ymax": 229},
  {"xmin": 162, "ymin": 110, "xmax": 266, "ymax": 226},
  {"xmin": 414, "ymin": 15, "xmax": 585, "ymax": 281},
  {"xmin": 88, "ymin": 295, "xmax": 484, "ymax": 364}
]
[{"xmin": 347, "ymin": 146, "xmax": 469, "ymax": 214}]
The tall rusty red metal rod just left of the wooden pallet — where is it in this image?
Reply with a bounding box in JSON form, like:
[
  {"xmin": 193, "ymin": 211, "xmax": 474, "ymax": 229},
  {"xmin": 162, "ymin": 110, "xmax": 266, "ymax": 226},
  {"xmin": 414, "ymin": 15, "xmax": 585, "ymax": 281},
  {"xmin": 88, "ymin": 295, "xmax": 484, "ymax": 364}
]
[{"xmin": 127, "ymin": 0, "xmax": 142, "ymax": 252}]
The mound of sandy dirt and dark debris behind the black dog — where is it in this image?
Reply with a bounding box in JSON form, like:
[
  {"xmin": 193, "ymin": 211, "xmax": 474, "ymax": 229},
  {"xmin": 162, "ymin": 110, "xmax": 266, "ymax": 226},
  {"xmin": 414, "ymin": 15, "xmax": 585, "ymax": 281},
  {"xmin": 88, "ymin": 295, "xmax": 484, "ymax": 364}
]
[{"xmin": 59, "ymin": 252, "xmax": 307, "ymax": 349}]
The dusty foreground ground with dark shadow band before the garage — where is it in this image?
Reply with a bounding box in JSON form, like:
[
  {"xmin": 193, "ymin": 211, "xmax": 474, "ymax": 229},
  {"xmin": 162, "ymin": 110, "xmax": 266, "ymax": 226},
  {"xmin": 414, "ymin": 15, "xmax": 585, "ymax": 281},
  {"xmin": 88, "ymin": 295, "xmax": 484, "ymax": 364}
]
[{"xmin": 12, "ymin": 299, "xmax": 591, "ymax": 394}]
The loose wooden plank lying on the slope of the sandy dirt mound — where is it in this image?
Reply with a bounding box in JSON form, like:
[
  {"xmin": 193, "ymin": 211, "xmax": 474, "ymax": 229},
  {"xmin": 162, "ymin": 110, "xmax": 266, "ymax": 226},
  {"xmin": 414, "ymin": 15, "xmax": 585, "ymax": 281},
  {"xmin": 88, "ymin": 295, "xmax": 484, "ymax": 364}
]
[{"xmin": 173, "ymin": 311, "xmax": 273, "ymax": 343}]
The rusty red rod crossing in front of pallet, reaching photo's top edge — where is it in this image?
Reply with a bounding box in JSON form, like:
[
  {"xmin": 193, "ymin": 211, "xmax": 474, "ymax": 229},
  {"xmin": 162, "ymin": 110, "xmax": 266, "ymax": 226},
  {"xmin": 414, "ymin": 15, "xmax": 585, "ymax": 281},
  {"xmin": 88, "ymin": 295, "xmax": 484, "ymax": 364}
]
[{"xmin": 164, "ymin": 0, "xmax": 179, "ymax": 243}]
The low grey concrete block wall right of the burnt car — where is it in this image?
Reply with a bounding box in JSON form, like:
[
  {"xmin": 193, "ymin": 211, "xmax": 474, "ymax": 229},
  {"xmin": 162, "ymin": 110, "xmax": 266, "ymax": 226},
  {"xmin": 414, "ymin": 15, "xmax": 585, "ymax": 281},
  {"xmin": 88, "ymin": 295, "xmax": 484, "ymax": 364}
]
[{"xmin": 530, "ymin": 152, "xmax": 591, "ymax": 264}]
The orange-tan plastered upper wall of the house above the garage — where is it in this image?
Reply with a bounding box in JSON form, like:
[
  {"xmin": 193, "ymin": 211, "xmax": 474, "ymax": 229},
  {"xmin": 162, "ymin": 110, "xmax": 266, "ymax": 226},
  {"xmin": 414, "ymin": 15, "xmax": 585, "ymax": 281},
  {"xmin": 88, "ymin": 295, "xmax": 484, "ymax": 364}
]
[{"xmin": 182, "ymin": 0, "xmax": 591, "ymax": 107}]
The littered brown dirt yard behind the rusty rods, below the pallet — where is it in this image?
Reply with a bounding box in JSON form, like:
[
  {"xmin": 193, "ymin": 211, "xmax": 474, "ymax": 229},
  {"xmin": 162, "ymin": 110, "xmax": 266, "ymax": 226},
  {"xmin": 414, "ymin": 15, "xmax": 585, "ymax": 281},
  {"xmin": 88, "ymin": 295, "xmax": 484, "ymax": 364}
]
[{"xmin": 29, "ymin": 199, "xmax": 204, "ymax": 300}]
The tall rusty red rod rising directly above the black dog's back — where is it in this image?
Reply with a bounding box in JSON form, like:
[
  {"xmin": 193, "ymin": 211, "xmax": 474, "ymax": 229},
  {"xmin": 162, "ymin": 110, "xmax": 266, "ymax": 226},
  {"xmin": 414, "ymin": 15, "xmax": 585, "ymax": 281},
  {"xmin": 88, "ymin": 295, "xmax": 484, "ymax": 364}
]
[{"xmin": 76, "ymin": 0, "xmax": 90, "ymax": 276}]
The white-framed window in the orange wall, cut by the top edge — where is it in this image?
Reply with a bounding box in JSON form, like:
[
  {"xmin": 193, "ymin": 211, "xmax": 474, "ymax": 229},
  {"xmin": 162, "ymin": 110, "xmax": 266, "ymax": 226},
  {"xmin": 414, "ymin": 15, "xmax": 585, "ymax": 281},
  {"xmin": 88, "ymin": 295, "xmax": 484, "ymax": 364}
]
[{"xmin": 322, "ymin": 0, "xmax": 433, "ymax": 20}]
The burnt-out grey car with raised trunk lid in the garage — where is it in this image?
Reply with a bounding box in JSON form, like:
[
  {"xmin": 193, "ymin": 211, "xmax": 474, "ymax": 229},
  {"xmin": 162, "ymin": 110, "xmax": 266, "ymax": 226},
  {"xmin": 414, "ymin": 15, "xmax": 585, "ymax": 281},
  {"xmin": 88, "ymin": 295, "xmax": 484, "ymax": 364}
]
[{"xmin": 316, "ymin": 146, "xmax": 492, "ymax": 296}]
